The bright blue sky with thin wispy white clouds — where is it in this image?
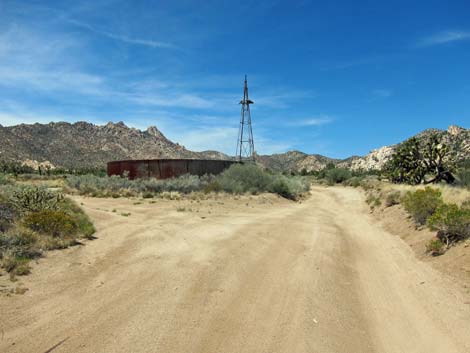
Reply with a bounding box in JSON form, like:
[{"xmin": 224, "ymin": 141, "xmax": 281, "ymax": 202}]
[{"xmin": 0, "ymin": 0, "xmax": 470, "ymax": 158}]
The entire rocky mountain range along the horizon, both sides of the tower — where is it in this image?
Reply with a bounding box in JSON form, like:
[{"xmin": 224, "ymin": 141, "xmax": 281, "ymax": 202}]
[{"xmin": 0, "ymin": 122, "xmax": 470, "ymax": 172}]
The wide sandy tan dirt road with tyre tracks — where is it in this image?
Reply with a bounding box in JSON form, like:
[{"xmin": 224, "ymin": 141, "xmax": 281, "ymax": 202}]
[{"xmin": 0, "ymin": 187, "xmax": 470, "ymax": 353}]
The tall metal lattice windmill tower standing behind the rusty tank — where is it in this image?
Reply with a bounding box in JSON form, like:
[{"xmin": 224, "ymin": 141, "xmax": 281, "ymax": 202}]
[{"xmin": 236, "ymin": 75, "xmax": 255, "ymax": 162}]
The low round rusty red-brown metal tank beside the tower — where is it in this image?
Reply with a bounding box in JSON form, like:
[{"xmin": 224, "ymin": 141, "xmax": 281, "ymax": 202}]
[{"xmin": 107, "ymin": 159, "xmax": 238, "ymax": 180}]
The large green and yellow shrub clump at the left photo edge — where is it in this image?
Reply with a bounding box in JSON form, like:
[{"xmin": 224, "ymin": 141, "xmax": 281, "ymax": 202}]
[{"xmin": 0, "ymin": 185, "xmax": 95, "ymax": 276}]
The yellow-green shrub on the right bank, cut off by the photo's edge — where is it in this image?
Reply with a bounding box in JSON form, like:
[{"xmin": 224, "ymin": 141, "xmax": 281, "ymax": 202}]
[{"xmin": 428, "ymin": 204, "xmax": 470, "ymax": 244}]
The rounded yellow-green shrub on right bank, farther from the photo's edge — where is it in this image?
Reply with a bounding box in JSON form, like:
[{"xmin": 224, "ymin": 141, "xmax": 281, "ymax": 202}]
[{"xmin": 401, "ymin": 187, "xmax": 443, "ymax": 225}]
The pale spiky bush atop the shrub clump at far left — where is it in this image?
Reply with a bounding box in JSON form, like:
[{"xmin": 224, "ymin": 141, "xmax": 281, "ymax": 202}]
[{"xmin": 11, "ymin": 187, "xmax": 64, "ymax": 213}]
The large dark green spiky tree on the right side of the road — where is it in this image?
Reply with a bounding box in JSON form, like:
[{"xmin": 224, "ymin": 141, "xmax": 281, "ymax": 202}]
[{"xmin": 384, "ymin": 134, "xmax": 455, "ymax": 185}]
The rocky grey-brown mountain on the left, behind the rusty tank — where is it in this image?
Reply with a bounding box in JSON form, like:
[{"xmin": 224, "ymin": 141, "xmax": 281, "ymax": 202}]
[{"xmin": 0, "ymin": 122, "xmax": 224, "ymax": 168}]
